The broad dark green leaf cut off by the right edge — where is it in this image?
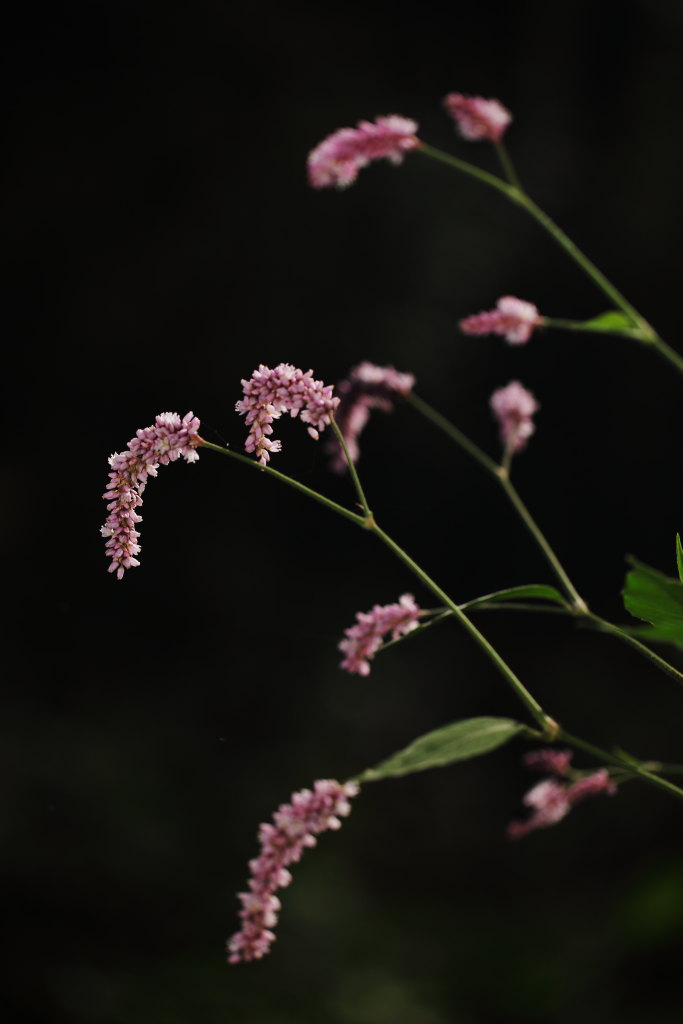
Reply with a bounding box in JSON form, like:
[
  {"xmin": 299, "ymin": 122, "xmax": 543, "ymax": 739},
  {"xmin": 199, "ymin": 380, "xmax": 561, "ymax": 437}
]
[{"xmin": 622, "ymin": 558, "xmax": 683, "ymax": 648}]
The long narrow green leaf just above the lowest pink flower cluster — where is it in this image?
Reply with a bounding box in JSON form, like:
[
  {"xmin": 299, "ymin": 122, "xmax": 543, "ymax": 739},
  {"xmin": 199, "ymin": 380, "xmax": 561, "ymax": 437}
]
[{"xmin": 360, "ymin": 718, "xmax": 525, "ymax": 782}]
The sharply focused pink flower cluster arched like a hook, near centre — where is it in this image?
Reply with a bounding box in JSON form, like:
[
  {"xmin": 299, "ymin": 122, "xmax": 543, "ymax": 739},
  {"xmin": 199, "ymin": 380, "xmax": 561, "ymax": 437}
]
[{"xmin": 234, "ymin": 362, "xmax": 339, "ymax": 466}]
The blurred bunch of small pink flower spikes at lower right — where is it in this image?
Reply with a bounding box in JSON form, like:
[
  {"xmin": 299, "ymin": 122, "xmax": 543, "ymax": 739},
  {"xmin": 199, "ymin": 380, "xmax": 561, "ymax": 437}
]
[{"xmin": 507, "ymin": 750, "xmax": 616, "ymax": 839}]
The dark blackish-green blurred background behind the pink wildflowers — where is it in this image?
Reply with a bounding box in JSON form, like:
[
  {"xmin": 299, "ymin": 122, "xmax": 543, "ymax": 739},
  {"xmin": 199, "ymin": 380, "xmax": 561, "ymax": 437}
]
[{"xmin": 5, "ymin": 0, "xmax": 683, "ymax": 1024}]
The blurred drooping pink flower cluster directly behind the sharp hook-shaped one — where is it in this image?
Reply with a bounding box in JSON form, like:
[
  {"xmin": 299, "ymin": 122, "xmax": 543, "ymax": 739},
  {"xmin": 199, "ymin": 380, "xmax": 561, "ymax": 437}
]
[{"xmin": 328, "ymin": 361, "xmax": 415, "ymax": 473}]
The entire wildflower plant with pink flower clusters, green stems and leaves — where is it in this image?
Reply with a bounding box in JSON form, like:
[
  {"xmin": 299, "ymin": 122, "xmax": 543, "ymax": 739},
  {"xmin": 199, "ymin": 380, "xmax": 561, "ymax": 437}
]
[{"xmin": 102, "ymin": 93, "xmax": 683, "ymax": 964}]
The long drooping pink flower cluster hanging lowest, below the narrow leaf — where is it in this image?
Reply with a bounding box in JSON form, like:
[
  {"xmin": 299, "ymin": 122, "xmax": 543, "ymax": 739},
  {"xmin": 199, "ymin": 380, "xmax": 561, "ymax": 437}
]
[{"xmin": 227, "ymin": 779, "xmax": 358, "ymax": 964}]
